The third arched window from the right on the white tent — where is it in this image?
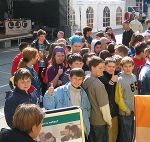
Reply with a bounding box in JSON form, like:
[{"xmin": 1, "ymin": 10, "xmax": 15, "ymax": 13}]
[{"xmin": 86, "ymin": 7, "xmax": 94, "ymax": 28}]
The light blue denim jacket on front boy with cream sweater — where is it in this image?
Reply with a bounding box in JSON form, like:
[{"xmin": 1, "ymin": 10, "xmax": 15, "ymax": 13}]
[{"xmin": 43, "ymin": 83, "xmax": 91, "ymax": 136}]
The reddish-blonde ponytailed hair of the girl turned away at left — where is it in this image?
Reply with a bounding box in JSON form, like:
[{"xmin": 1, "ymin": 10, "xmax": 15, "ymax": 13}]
[{"xmin": 18, "ymin": 47, "xmax": 38, "ymax": 69}]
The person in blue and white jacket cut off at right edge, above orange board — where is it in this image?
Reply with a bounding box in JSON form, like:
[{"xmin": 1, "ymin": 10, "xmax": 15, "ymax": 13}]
[{"xmin": 139, "ymin": 47, "xmax": 150, "ymax": 95}]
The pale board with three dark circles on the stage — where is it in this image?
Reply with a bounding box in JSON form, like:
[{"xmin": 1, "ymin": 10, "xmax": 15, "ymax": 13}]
[{"xmin": 5, "ymin": 20, "xmax": 31, "ymax": 35}]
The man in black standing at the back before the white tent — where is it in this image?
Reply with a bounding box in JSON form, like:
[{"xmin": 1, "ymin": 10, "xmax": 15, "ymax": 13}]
[{"xmin": 122, "ymin": 21, "xmax": 134, "ymax": 47}]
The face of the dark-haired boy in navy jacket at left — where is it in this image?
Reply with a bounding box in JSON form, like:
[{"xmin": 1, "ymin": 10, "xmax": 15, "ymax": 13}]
[{"xmin": 16, "ymin": 78, "xmax": 31, "ymax": 92}]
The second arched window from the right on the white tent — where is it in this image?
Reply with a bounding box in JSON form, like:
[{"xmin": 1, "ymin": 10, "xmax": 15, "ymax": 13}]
[{"xmin": 103, "ymin": 6, "xmax": 110, "ymax": 27}]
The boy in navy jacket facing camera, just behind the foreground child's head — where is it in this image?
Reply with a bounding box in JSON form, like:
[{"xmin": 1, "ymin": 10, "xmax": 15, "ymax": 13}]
[{"xmin": 4, "ymin": 68, "xmax": 38, "ymax": 127}]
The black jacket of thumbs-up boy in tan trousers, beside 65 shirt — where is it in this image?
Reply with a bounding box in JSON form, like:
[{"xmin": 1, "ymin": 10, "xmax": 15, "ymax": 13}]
[{"xmin": 99, "ymin": 71, "xmax": 118, "ymax": 117}]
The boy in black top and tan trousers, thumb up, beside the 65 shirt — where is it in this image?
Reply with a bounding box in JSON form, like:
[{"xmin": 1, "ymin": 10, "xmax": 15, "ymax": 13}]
[{"xmin": 99, "ymin": 57, "xmax": 118, "ymax": 142}]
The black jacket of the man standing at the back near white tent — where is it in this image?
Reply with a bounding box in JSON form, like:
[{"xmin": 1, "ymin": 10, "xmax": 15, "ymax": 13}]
[{"xmin": 122, "ymin": 29, "xmax": 134, "ymax": 47}]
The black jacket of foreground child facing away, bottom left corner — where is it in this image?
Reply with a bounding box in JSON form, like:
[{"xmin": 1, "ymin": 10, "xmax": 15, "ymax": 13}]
[{"xmin": 0, "ymin": 128, "xmax": 36, "ymax": 142}]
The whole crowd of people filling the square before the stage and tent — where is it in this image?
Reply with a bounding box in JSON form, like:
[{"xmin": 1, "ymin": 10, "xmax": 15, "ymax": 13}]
[{"xmin": 0, "ymin": 17, "xmax": 150, "ymax": 142}]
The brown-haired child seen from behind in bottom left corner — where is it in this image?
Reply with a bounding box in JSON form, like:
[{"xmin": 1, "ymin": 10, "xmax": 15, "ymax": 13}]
[{"xmin": 0, "ymin": 103, "xmax": 44, "ymax": 142}]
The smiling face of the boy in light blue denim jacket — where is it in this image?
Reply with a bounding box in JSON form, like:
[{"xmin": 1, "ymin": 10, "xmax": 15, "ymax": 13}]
[{"xmin": 69, "ymin": 75, "xmax": 83, "ymax": 88}]
